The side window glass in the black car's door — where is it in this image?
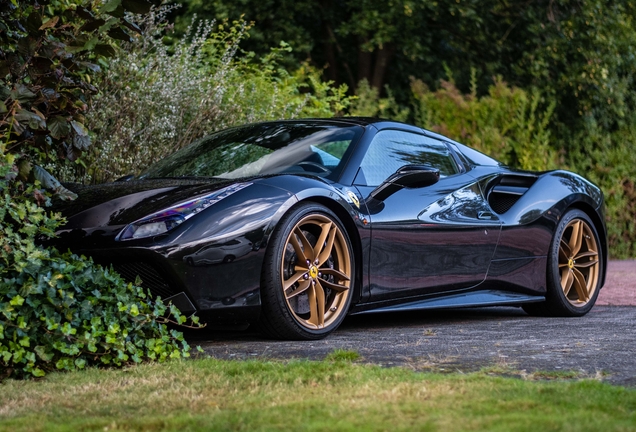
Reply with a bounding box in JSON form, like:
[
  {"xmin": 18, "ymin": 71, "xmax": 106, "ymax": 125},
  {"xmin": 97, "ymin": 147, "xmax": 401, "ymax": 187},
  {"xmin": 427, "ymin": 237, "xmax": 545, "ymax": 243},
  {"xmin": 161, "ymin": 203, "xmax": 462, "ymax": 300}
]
[{"xmin": 356, "ymin": 130, "xmax": 459, "ymax": 186}]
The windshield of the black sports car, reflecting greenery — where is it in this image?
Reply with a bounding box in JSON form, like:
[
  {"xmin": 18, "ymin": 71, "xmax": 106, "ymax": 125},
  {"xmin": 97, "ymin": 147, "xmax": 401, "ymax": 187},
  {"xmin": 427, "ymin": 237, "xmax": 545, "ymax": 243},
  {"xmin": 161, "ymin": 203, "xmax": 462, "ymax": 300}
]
[{"xmin": 140, "ymin": 122, "xmax": 363, "ymax": 180}]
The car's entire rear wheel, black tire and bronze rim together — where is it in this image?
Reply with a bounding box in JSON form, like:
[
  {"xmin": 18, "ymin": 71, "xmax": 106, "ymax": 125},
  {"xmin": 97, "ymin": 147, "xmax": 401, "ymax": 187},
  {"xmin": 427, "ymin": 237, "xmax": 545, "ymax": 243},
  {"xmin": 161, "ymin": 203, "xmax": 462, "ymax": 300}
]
[{"xmin": 523, "ymin": 210, "xmax": 603, "ymax": 317}]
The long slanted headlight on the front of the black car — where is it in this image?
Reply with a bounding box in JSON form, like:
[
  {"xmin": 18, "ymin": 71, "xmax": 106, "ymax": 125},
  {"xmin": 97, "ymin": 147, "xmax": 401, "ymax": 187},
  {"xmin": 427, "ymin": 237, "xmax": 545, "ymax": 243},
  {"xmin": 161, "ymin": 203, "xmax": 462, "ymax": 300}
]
[{"xmin": 116, "ymin": 183, "xmax": 251, "ymax": 240}]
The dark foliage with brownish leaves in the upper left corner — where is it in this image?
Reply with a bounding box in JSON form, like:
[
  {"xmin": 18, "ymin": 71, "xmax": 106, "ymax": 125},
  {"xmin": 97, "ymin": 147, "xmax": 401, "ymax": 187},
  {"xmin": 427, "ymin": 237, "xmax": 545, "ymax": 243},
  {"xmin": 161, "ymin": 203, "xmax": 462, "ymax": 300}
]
[{"xmin": 0, "ymin": 0, "xmax": 161, "ymax": 170}]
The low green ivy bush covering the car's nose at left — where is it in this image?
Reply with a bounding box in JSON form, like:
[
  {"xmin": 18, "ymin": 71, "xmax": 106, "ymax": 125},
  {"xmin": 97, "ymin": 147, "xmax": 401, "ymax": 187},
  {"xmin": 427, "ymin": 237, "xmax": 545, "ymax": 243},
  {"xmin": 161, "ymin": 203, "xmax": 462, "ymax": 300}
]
[{"xmin": 0, "ymin": 152, "xmax": 190, "ymax": 380}]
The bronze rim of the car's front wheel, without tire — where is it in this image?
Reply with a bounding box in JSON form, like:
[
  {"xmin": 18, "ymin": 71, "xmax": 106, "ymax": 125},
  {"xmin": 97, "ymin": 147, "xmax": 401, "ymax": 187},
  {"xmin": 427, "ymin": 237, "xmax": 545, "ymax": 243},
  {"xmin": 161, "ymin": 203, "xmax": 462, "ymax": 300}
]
[{"xmin": 280, "ymin": 213, "xmax": 352, "ymax": 330}]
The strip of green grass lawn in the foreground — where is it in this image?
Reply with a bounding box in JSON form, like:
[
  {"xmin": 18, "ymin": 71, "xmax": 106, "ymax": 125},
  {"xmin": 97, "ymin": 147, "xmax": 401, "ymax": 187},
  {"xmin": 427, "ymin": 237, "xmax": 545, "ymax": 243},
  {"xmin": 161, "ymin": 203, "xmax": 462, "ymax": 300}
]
[{"xmin": 0, "ymin": 351, "xmax": 636, "ymax": 432}]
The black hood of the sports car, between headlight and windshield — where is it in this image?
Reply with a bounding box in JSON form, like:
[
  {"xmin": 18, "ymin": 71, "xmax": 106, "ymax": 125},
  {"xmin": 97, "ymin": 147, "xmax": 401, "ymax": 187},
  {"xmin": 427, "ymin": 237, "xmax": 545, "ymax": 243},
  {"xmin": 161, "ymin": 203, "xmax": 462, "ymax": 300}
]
[{"xmin": 53, "ymin": 179, "xmax": 241, "ymax": 229}]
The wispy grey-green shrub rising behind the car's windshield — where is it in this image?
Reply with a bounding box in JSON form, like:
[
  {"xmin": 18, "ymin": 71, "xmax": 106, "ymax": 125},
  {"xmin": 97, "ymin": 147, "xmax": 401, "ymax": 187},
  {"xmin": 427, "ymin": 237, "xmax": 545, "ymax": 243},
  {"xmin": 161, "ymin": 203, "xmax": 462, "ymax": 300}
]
[{"xmin": 74, "ymin": 7, "xmax": 348, "ymax": 182}]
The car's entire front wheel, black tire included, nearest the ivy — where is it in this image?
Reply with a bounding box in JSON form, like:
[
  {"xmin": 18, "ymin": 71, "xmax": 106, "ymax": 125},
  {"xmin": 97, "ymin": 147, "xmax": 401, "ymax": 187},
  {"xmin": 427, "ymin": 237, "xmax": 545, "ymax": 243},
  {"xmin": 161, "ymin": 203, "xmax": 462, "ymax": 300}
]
[{"xmin": 259, "ymin": 203, "xmax": 355, "ymax": 340}]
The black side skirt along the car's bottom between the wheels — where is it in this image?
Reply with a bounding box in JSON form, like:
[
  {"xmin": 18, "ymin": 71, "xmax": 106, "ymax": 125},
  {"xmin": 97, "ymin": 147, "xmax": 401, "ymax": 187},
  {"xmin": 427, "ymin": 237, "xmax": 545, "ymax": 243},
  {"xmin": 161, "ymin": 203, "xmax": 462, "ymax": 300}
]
[{"xmin": 351, "ymin": 290, "xmax": 545, "ymax": 315}]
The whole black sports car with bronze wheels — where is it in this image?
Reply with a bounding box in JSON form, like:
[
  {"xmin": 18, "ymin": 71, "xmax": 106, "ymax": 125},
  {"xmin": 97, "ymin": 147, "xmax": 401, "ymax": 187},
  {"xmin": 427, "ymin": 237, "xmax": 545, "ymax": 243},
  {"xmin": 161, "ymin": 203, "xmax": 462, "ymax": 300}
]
[{"xmin": 53, "ymin": 118, "xmax": 607, "ymax": 339}]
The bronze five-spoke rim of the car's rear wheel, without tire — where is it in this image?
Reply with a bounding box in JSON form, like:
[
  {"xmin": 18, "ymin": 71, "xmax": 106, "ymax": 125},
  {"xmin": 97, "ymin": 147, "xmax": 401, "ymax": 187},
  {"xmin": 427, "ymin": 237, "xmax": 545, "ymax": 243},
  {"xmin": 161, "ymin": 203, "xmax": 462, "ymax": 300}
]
[{"xmin": 559, "ymin": 218, "xmax": 600, "ymax": 307}]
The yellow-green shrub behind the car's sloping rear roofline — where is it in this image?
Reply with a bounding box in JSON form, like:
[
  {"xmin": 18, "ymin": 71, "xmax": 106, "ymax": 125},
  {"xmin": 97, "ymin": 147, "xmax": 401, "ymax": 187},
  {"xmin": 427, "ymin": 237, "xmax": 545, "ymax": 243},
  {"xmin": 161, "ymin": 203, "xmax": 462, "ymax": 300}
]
[{"xmin": 411, "ymin": 72, "xmax": 556, "ymax": 171}]
